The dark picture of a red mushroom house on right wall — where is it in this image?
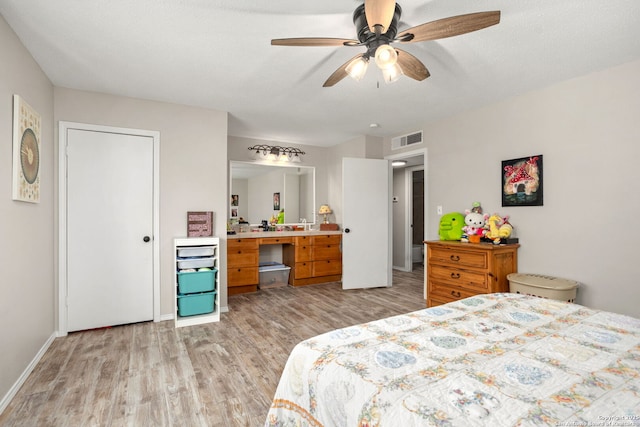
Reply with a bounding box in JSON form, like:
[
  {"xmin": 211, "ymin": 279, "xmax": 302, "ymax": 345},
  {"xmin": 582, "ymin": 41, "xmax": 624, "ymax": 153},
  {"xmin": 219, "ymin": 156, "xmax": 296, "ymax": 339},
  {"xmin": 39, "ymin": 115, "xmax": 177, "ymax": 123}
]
[{"xmin": 502, "ymin": 154, "xmax": 543, "ymax": 206}]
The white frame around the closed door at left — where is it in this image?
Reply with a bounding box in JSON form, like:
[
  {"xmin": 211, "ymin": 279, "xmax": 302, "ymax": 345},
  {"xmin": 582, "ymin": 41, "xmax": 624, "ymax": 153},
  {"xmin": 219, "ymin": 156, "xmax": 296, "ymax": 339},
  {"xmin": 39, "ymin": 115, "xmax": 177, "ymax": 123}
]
[{"xmin": 57, "ymin": 121, "xmax": 161, "ymax": 337}]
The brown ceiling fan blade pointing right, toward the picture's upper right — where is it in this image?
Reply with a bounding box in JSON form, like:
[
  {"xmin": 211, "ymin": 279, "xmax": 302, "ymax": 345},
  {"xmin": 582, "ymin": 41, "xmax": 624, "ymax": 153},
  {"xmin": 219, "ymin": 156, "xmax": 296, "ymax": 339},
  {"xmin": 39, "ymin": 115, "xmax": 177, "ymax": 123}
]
[{"xmin": 396, "ymin": 10, "xmax": 500, "ymax": 43}]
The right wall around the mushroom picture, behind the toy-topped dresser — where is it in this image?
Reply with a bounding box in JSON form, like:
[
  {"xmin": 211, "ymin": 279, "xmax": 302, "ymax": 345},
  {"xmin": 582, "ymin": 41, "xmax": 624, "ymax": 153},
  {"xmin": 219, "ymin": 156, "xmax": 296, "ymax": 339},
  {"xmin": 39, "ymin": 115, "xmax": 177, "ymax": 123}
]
[{"xmin": 385, "ymin": 61, "xmax": 640, "ymax": 317}]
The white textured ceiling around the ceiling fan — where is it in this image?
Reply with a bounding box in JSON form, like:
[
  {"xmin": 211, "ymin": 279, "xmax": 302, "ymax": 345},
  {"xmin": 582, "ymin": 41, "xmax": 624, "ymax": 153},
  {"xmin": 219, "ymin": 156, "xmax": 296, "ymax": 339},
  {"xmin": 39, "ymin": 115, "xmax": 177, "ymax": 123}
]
[{"xmin": 0, "ymin": 0, "xmax": 640, "ymax": 146}]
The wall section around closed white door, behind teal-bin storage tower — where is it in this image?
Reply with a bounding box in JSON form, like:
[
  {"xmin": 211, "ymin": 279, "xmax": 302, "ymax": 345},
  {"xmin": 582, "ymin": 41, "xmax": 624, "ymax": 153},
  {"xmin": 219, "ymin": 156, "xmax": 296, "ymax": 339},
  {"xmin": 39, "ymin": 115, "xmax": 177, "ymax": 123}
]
[{"xmin": 55, "ymin": 88, "xmax": 229, "ymax": 315}]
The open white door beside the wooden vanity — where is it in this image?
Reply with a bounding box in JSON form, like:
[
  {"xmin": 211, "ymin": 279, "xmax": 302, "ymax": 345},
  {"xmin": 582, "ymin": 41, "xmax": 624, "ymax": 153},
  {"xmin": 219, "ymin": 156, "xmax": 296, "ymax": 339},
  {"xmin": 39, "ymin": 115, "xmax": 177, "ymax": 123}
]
[{"xmin": 342, "ymin": 158, "xmax": 392, "ymax": 289}]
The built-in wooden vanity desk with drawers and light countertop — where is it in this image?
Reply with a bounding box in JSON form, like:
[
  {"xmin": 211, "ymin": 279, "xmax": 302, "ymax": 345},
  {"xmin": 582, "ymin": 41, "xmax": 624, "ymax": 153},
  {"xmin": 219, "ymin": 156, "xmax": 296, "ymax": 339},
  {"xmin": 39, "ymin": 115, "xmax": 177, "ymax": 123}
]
[{"xmin": 227, "ymin": 231, "xmax": 342, "ymax": 295}]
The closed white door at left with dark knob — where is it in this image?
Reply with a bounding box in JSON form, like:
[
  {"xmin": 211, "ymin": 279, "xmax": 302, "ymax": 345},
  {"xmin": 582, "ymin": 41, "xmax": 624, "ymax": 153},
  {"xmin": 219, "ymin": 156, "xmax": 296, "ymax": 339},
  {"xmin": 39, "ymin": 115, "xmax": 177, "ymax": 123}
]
[{"xmin": 66, "ymin": 129, "xmax": 154, "ymax": 331}]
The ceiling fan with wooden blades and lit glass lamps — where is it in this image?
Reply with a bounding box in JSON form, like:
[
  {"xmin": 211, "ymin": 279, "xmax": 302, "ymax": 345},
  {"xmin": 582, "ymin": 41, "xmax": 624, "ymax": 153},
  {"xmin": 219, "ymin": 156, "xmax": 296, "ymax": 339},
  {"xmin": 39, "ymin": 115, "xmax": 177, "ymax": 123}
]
[{"xmin": 271, "ymin": 0, "xmax": 500, "ymax": 87}]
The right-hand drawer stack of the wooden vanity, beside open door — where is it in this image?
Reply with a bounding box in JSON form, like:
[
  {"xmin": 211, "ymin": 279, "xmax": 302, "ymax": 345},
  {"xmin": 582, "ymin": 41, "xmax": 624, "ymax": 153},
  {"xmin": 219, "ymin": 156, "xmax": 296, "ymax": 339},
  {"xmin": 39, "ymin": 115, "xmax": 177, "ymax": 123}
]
[{"xmin": 282, "ymin": 234, "xmax": 342, "ymax": 286}]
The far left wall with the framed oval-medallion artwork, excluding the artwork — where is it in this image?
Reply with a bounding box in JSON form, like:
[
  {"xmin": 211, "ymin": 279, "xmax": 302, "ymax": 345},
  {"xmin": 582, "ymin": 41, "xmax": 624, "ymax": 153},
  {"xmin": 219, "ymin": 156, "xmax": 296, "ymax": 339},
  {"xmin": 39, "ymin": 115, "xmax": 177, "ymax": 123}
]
[{"xmin": 0, "ymin": 16, "xmax": 55, "ymax": 410}]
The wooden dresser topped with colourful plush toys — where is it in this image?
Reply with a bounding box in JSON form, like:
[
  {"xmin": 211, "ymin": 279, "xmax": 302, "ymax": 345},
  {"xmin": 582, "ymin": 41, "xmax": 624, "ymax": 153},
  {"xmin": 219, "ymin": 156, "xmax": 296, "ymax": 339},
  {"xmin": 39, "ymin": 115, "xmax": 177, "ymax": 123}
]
[{"xmin": 425, "ymin": 241, "xmax": 520, "ymax": 307}]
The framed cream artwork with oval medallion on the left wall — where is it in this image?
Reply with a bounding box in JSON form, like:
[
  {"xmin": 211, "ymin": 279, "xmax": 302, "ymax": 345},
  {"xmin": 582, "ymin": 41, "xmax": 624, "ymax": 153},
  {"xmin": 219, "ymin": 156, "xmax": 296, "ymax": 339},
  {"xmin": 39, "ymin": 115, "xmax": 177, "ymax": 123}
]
[{"xmin": 12, "ymin": 95, "xmax": 41, "ymax": 203}]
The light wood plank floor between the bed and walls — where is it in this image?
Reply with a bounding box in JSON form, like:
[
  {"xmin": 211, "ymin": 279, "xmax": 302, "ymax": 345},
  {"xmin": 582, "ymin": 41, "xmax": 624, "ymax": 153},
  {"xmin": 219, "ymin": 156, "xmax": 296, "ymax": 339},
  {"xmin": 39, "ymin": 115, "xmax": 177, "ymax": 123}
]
[{"xmin": 0, "ymin": 265, "xmax": 425, "ymax": 427}]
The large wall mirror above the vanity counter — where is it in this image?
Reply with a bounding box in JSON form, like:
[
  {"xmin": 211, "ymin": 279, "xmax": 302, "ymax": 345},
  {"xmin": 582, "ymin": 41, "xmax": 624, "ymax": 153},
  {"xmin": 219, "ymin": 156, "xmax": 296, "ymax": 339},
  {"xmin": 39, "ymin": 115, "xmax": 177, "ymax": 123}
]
[{"xmin": 229, "ymin": 161, "xmax": 316, "ymax": 225}]
